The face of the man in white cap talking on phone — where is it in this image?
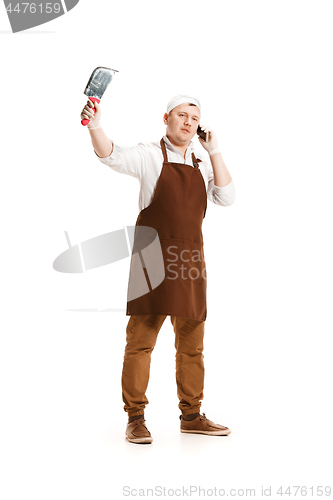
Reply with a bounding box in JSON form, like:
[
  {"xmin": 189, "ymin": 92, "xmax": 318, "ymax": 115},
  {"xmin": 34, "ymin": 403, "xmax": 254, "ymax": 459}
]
[{"xmin": 164, "ymin": 104, "xmax": 200, "ymax": 146}]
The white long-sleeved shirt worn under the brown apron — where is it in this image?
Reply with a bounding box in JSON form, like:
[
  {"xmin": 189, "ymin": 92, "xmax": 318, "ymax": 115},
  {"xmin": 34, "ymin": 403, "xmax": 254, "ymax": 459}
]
[{"xmin": 98, "ymin": 136, "xmax": 236, "ymax": 211}]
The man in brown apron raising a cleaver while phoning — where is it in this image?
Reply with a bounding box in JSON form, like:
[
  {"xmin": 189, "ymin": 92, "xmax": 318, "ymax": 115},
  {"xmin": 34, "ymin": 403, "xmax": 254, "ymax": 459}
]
[{"xmin": 81, "ymin": 95, "xmax": 235, "ymax": 443}]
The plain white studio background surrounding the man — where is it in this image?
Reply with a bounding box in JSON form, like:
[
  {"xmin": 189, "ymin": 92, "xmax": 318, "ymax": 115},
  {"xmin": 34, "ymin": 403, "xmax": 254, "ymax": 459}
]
[{"xmin": 0, "ymin": 0, "xmax": 333, "ymax": 500}]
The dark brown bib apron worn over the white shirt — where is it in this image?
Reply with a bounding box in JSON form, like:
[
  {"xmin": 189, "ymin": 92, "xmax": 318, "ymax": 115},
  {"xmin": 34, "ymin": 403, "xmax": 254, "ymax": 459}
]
[{"xmin": 126, "ymin": 139, "xmax": 207, "ymax": 321}]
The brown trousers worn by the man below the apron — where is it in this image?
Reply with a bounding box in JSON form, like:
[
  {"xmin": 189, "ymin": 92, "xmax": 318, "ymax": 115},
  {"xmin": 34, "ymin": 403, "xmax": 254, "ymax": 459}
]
[{"xmin": 122, "ymin": 314, "xmax": 205, "ymax": 417}]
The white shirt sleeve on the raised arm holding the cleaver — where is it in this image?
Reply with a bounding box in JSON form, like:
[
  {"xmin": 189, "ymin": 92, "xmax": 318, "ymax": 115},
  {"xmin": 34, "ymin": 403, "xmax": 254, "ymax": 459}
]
[{"xmin": 96, "ymin": 139, "xmax": 145, "ymax": 180}]
